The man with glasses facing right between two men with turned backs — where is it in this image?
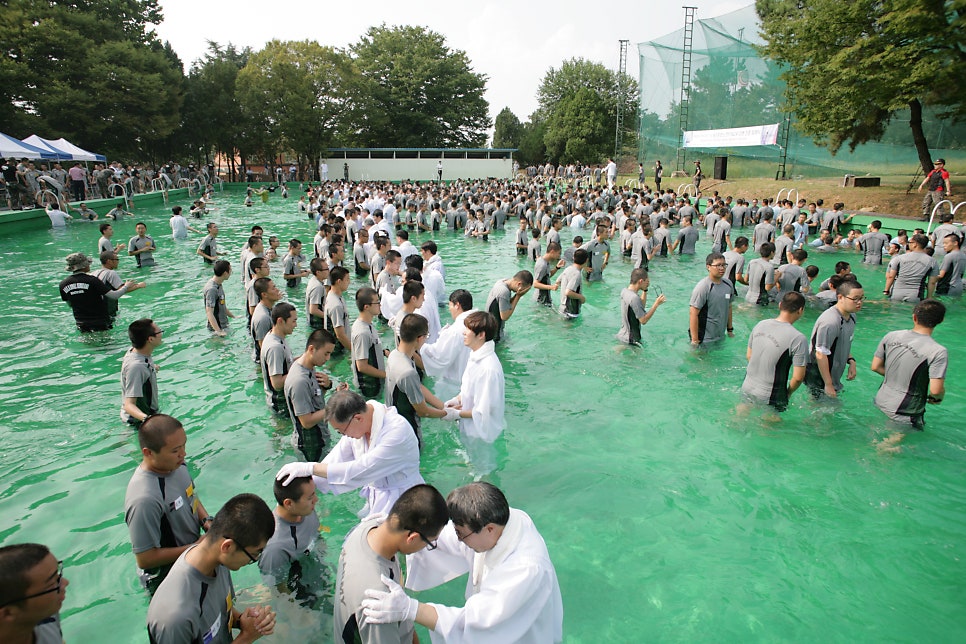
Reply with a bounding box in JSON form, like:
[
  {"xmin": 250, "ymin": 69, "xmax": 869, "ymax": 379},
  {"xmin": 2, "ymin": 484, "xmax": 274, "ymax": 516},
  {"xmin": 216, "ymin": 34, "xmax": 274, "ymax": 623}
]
[{"xmin": 805, "ymin": 279, "xmax": 865, "ymax": 398}]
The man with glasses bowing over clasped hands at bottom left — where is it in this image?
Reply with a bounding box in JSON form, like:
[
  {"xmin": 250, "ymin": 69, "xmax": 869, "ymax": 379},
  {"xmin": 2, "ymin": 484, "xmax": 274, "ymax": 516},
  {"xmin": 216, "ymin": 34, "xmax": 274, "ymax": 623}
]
[{"xmin": 147, "ymin": 494, "xmax": 275, "ymax": 644}]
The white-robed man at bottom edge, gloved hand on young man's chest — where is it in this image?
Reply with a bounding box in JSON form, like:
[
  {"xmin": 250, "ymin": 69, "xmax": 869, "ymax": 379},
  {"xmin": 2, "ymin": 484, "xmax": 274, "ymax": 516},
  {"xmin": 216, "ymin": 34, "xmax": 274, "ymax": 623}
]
[{"xmin": 362, "ymin": 481, "xmax": 563, "ymax": 644}]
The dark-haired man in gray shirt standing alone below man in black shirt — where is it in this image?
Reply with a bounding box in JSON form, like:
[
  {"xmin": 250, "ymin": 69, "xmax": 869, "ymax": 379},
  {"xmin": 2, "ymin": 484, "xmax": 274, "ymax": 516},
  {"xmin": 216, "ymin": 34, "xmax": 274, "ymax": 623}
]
[{"xmin": 121, "ymin": 318, "xmax": 164, "ymax": 427}]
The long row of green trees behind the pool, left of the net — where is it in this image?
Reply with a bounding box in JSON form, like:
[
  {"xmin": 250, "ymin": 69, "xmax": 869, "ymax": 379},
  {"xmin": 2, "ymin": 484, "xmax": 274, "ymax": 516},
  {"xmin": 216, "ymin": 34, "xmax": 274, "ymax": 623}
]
[{"xmin": 0, "ymin": 0, "xmax": 637, "ymax": 174}]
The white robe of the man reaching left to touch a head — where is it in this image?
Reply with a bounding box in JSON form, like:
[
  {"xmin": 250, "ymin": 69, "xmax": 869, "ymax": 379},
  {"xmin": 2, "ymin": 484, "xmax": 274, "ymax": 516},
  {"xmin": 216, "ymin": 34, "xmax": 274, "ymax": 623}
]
[{"xmin": 313, "ymin": 400, "xmax": 425, "ymax": 519}]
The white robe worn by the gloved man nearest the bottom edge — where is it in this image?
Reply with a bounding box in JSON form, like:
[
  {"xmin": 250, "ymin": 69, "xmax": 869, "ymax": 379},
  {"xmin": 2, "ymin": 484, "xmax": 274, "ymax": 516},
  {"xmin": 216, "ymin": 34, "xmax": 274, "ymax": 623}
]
[{"xmin": 406, "ymin": 508, "xmax": 563, "ymax": 644}]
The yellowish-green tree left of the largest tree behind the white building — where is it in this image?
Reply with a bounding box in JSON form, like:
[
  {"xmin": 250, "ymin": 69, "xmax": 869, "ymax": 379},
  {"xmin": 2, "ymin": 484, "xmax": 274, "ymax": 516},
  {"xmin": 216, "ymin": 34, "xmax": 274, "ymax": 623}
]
[{"xmin": 238, "ymin": 40, "xmax": 356, "ymax": 179}]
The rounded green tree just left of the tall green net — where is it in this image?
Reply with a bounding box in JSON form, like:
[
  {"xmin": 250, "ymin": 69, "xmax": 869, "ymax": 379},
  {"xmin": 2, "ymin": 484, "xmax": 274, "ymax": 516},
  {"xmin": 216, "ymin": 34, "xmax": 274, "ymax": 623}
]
[{"xmin": 531, "ymin": 58, "xmax": 638, "ymax": 163}]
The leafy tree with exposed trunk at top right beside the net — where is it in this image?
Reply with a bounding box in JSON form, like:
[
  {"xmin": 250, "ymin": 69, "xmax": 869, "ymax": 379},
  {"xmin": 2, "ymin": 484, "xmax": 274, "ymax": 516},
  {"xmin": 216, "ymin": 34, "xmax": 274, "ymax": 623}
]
[{"xmin": 756, "ymin": 0, "xmax": 966, "ymax": 171}]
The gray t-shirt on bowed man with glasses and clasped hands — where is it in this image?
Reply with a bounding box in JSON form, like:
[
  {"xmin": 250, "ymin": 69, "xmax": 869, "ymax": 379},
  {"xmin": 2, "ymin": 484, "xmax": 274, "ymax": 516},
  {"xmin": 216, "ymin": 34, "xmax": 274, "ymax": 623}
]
[{"xmin": 148, "ymin": 546, "xmax": 235, "ymax": 644}]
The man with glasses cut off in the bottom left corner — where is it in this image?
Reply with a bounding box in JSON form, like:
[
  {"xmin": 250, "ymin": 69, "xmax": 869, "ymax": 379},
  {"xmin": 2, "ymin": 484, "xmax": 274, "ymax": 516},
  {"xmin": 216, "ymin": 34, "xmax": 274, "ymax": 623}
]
[{"xmin": 0, "ymin": 543, "xmax": 70, "ymax": 644}]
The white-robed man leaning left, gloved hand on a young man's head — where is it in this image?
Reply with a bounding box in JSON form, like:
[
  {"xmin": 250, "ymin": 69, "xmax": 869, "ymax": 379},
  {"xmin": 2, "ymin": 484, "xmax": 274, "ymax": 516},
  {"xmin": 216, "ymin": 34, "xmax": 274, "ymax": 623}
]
[{"xmin": 275, "ymin": 390, "xmax": 425, "ymax": 519}]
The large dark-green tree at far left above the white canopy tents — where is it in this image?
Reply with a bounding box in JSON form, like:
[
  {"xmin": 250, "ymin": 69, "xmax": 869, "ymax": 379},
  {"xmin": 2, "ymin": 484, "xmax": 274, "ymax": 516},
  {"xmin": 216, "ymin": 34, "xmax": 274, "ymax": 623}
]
[{"xmin": 0, "ymin": 0, "xmax": 183, "ymax": 158}]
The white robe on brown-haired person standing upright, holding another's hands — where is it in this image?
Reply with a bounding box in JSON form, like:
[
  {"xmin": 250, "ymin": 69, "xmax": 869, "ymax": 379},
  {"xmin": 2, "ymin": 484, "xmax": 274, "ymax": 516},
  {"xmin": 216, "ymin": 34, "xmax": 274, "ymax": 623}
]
[{"xmin": 460, "ymin": 340, "xmax": 506, "ymax": 443}]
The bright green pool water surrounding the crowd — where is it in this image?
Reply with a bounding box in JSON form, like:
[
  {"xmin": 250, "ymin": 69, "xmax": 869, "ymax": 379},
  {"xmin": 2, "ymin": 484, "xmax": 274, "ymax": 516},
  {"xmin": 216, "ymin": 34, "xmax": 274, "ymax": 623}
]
[{"xmin": 0, "ymin": 193, "xmax": 966, "ymax": 643}]
